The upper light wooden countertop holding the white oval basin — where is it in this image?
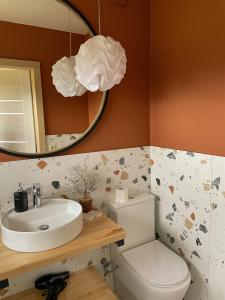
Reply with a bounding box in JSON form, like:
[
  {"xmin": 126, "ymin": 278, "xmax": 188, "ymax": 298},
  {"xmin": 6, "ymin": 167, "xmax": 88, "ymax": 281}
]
[{"xmin": 0, "ymin": 216, "xmax": 126, "ymax": 280}]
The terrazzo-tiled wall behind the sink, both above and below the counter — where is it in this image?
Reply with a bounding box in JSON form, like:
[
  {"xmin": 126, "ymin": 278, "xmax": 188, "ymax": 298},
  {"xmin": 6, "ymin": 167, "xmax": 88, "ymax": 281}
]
[{"xmin": 0, "ymin": 147, "xmax": 151, "ymax": 299}]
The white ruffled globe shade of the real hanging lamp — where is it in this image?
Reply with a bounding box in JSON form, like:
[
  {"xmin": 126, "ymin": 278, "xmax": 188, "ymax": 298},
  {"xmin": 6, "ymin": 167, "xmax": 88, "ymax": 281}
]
[{"xmin": 75, "ymin": 35, "xmax": 127, "ymax": 92}]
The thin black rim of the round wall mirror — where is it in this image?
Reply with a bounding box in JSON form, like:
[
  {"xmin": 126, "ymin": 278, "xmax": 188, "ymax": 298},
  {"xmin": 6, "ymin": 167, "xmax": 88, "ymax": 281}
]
[{"xmin": 0, "ymin": 0, "xmax": 109, "ymax": 158}]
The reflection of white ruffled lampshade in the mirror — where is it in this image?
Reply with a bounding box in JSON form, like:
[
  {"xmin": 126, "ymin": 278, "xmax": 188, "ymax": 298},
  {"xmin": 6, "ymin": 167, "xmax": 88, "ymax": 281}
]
[{"xmin": 52, "ymin": 56, "xmax": 87, "ymax": 97}]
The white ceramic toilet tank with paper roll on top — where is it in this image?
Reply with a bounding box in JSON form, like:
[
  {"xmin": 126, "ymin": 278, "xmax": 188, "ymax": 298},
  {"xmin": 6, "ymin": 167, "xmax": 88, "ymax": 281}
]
[{"xmin": 108, "ymin": 192, "xmax": 155, "ymax": 252}]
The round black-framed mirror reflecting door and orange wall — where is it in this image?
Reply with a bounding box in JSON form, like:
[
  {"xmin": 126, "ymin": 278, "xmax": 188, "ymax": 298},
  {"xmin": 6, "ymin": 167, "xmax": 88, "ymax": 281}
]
[{"xmin": 0, "ymin": 0, "xmax": 108, "ymax": 158}]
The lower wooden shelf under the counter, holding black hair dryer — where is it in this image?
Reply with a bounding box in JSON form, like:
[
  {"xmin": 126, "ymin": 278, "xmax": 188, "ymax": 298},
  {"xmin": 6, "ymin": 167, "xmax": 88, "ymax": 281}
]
[{"xmin": 5, "ymin": 267, "xmax": 118, "ymax": 300}]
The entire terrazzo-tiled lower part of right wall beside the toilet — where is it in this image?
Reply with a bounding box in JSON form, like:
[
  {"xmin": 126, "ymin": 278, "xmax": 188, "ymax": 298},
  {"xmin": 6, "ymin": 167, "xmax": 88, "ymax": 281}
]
[{"xmin": 151, "ymin": 147, "xmax": 225, "ymax": 300}]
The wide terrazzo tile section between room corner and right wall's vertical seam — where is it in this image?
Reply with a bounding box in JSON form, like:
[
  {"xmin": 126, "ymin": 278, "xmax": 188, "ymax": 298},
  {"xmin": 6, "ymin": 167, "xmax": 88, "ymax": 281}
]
[{"xmin": 151, "ymin": 147, "xmax": 211, "ymax": 300}]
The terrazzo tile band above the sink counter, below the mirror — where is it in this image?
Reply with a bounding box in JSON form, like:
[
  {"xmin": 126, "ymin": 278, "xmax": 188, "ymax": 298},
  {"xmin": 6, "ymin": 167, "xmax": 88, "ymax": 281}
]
[{"xmin": 0, "ymin": 147, "xmax": 150, "ymax": 212}]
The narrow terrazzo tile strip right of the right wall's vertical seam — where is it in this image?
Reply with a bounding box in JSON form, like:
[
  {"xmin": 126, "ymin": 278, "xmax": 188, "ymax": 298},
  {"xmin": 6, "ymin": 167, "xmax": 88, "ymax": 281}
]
[{"xmin": 208, "ymin": 156, "xmax": 225, "ymax": 300}]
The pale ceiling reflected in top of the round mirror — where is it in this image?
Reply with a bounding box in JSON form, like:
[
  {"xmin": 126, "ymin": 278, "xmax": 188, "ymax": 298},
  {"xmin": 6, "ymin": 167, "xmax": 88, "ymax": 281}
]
[{"xmin": 0, "ymin": 0, "xmax": 88, "ymax": 34}]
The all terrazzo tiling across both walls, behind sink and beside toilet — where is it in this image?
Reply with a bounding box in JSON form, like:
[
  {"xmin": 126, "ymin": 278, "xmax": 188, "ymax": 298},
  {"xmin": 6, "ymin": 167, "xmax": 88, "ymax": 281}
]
[{"xmin": 0, "ymin": 147, "xmax": 225, "ymax": 300}]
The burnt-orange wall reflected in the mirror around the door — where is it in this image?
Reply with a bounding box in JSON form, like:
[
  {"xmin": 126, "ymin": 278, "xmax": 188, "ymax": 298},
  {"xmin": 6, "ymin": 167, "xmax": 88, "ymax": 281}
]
[{"xmin": 0, "ymin": 22, "xmax": 88, "ymax": 134}]
